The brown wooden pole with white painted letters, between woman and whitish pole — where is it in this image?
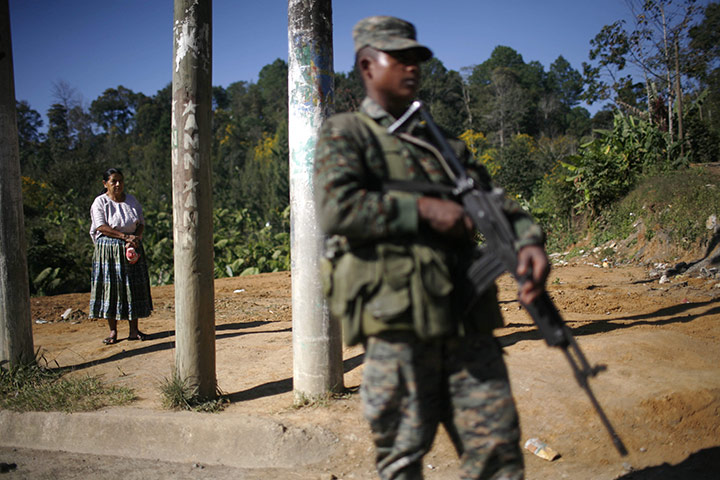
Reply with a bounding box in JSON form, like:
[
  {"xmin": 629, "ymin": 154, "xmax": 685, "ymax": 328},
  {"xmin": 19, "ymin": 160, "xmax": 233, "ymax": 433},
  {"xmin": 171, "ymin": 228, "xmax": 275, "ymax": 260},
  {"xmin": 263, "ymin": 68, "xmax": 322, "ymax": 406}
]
[{"xmin": 171, "ymin": 0, "xmax": 217, "ymax": 400}]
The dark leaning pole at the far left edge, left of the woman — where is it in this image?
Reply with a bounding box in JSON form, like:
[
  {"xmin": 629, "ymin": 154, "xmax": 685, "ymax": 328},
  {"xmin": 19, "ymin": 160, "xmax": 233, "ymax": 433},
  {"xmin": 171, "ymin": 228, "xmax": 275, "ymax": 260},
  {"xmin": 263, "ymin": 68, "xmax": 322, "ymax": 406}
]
[{"xmin": 0, "ymin": 0, "xmax": 35, "ymax": 365}]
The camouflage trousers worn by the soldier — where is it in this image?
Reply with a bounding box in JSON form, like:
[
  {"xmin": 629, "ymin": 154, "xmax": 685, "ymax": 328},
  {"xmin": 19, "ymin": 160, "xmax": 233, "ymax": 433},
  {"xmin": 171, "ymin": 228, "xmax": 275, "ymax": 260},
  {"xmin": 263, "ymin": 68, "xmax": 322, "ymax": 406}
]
[{"xmin": 360, "ymin": 332, "xmax": 523, "ymax": 480}]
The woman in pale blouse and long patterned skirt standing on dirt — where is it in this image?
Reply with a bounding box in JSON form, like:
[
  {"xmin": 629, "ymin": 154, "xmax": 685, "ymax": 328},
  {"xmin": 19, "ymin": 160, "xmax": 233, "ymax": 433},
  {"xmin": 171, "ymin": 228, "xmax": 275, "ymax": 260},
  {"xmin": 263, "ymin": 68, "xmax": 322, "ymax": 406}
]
[{"xmin": 89, "ymin": 168, "xmax": 153, "ymax": 345}]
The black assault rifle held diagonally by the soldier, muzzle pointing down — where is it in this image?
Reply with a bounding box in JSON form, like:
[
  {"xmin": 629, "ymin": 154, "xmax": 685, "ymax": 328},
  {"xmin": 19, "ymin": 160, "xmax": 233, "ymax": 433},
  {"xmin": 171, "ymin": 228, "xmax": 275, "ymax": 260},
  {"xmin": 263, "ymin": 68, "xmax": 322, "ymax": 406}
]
[{"xmin": 388, "ymin": 101, "xmax": 627, "ymax": 456}]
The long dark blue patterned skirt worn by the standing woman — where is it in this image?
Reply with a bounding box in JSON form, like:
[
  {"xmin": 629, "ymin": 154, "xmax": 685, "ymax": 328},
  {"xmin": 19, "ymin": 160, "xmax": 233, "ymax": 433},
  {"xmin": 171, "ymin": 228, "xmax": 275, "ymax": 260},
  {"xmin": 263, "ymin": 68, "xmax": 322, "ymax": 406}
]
[{"xmin": 89, "ymin": 236, "xmax": 153, "ymax": 320}]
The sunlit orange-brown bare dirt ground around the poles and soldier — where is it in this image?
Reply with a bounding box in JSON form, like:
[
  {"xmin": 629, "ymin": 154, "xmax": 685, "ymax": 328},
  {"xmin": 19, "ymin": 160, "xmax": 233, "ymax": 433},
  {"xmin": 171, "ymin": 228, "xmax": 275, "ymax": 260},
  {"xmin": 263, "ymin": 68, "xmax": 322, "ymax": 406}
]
[{"xmin": 0, "ymin": 251, "xmax": 720, "ymax": 480}]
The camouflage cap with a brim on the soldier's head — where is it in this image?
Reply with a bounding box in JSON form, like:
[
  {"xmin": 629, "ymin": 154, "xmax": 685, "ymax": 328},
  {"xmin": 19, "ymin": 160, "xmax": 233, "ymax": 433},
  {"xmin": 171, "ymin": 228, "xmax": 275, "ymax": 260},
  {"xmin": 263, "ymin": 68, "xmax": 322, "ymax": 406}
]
[{"xmin": 353, "ymin": 16, "xmax": 432, "ymax": 60}]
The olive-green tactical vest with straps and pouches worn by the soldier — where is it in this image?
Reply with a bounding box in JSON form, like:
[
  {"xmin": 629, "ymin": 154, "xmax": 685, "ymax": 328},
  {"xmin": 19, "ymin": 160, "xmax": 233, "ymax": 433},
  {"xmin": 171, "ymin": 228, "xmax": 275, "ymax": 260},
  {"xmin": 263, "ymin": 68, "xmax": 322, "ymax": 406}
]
[{"xmin": 322, "ymin": 112, "xmax": 502, "ymax": 345}]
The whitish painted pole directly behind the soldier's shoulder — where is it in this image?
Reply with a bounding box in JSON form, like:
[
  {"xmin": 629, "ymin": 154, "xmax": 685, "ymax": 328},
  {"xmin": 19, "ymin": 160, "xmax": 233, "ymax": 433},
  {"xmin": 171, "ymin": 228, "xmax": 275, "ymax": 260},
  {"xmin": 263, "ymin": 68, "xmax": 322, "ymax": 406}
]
[{"xmin": 288, "ymin": 0, "xmax": 343, "ymax": 403}]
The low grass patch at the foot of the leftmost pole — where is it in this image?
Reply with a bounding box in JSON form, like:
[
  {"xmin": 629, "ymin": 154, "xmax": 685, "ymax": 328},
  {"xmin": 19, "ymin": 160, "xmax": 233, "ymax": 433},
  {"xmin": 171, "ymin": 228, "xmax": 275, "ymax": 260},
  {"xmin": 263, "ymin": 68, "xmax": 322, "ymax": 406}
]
[{"xmin": 0, "ymin": 361, "xmax": 135, "ymax": 413}]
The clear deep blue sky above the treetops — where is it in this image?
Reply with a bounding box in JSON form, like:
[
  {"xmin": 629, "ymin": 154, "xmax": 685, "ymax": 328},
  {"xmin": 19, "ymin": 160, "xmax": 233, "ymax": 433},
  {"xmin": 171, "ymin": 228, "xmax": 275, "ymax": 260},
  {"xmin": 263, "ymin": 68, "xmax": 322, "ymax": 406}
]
[{"xmin": 9, "ymin": 0, "xmax": 652, "ymax": 122}]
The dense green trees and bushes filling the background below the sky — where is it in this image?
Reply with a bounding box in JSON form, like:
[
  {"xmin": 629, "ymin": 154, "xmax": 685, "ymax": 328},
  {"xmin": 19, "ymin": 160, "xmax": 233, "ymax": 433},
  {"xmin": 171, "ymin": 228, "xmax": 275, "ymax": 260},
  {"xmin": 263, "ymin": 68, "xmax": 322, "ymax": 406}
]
[{"xmin": 17, "ymin": 0, "xmax": 720, "ymax": 295}]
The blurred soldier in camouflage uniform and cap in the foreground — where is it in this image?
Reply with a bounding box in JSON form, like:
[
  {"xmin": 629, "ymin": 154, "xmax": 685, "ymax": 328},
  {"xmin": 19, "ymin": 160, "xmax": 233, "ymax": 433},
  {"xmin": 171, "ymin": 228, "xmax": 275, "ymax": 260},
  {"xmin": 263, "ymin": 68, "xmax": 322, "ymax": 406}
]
[{"xmin": 314, "ymin": 16, "xmax": 549, "ymax": 480}]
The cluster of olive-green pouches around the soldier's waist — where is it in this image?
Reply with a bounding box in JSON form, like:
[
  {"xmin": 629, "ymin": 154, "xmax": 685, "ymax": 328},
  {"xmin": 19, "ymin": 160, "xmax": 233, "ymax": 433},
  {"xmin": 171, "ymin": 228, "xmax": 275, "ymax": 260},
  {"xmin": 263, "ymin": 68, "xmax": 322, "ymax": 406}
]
[{"xmin": 322, "ymin": 243, "xmax": 457, "ymax": 345}]
